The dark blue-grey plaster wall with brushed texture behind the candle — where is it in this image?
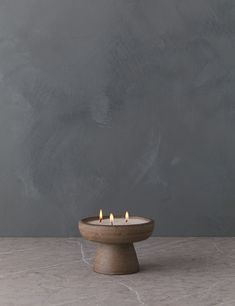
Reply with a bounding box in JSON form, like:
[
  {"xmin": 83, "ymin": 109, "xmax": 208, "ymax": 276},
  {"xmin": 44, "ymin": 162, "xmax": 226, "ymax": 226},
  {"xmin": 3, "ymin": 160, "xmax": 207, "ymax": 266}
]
[{"xmin": 0, "ymin": 0, "xmax": 235, "ymax": 236}]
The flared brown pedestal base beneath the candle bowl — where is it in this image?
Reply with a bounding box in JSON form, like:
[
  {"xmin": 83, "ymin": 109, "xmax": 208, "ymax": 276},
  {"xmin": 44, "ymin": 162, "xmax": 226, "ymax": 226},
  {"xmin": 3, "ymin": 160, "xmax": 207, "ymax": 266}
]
[{"xmin": 94, "ymin": 243, "xmax": 139, "ymax": 274}]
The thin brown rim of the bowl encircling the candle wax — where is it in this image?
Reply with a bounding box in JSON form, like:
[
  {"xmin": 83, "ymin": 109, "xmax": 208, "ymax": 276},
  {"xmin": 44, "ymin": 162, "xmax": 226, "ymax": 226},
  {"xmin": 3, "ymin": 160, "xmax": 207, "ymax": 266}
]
[{"xmin": 79, "ymin": 215, "xmax": 155, "ymax": 228}]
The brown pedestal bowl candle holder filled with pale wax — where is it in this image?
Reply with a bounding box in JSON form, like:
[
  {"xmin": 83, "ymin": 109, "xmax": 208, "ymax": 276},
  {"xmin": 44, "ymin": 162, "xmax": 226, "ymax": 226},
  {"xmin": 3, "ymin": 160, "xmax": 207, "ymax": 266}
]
[{"xmin": 79, "ymin": 216, "xmax": 154, "ymax": 274}]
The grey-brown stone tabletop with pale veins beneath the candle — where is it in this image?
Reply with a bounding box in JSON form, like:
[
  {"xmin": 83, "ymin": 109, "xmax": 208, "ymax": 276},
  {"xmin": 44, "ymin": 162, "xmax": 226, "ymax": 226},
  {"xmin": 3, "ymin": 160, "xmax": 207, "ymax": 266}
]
[{"xmin": 0, "ymin": 237, "xmax": 235, "ymax": 306}]
